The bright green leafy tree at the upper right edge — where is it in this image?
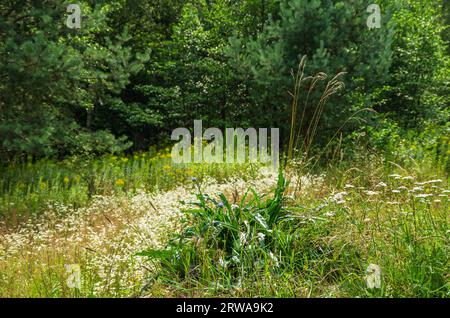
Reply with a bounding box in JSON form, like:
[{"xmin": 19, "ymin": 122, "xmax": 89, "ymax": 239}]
[{"xmin": 375, "ymin": 0, "xmax": 450, "ymax": 128}]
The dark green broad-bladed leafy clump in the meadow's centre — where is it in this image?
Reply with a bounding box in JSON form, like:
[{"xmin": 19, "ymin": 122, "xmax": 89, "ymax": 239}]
[{"xmin": 140, "ymin": 173, "xmax": 293, "ymax": 284}]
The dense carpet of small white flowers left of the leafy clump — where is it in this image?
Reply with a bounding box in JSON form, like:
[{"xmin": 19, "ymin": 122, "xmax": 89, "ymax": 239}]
[{"xmin": 0, "ymin": 168, "xmax": 284, "ymax": 296}]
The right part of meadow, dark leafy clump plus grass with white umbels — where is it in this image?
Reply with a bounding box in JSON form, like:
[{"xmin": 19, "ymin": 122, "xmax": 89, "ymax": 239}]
[{"xmin": 140, "ymin": 155, "xmax": 450, "ymax": 297}]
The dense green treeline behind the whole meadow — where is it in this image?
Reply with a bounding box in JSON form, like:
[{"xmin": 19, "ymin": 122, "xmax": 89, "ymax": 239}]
[{"xmin": 0, "ymin": 0, "xmax": 450, "ymax": 163}]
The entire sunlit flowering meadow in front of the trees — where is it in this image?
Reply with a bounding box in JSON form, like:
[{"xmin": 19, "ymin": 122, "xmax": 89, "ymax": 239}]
[{"xmin": 0, "ymin": 139, "xmax": 450, "ymax": 297}]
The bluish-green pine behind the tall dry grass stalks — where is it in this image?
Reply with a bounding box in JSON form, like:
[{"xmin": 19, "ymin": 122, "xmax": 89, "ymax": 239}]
[{"xmin": 229, "ymin": 0, "xmax": 392, "ymax": 144}]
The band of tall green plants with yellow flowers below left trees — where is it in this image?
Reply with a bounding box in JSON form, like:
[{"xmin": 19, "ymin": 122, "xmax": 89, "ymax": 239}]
[{"xmin": 0, "ymin": 148, "xmax": 262, "ymax": 225}]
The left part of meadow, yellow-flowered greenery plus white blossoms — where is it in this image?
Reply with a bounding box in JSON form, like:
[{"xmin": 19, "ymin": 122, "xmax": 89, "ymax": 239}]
[{"xmin": 0, "ymin": 150, "xmax": 268, "ymax": 297}]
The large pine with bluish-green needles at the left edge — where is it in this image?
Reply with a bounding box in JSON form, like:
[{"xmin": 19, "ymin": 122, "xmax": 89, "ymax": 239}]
[{"xmin": 0, "ymin": 0, "xmax": 146, "ymax": 160}]
